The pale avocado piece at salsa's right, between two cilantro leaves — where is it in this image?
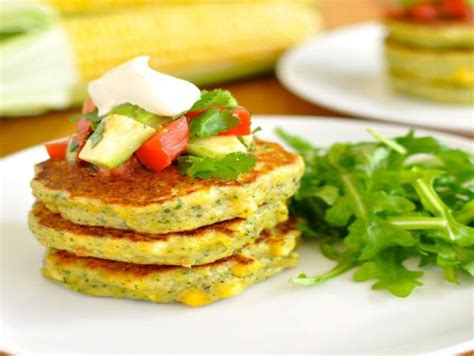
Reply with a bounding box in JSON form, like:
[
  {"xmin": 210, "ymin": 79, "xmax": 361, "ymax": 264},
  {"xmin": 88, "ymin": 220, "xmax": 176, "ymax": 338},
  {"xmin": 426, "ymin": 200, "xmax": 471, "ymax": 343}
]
[{"xmin": 188, "ymin": 136, "xmax": 247, "ymax": 158}]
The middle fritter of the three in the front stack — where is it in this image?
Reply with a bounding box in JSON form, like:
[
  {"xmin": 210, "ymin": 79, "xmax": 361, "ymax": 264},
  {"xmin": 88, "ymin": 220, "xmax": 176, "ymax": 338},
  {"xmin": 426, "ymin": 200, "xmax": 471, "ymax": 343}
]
[{"xmin": 28, "ymin": 202, "xmax": 288, "ymax": 267}]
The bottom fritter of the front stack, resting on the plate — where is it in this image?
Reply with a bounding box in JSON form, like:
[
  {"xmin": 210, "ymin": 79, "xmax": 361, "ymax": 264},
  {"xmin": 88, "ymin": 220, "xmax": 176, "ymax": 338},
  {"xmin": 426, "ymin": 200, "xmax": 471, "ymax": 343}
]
[{"xmin": 43, "ymin": 220, "xmax": 300, "ymax": 306}]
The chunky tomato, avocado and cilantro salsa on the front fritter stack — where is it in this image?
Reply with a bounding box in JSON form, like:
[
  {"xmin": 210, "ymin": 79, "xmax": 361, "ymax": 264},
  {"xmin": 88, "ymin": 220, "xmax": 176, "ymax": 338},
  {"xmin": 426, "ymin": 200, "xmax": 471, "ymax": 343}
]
[{"xmin": 46, "ymin": 89, "xmax": 256, "ymax": 180}]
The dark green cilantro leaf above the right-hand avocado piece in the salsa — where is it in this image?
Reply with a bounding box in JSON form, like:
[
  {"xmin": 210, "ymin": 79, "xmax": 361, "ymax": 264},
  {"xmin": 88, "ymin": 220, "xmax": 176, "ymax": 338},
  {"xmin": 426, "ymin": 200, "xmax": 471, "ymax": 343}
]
[{"xmin": 189, "ymin": 109, "xmax": 240, "ymax": 137}]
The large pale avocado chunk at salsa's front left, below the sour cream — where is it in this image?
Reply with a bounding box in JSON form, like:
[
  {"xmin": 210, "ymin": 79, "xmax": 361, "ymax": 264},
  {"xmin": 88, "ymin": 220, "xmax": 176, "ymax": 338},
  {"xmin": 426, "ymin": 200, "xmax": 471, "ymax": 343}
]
[{"xmin": 79, "ymin": 114, "xmax": 156, "ymax": 168}]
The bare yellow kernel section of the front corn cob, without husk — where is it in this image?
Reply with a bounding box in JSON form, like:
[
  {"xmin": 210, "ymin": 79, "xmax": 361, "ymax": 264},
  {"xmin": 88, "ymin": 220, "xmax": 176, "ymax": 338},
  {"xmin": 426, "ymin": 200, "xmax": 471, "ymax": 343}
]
[{"xmin": 63, "ymin": 3, "xmax": 318, "ymax": 82}]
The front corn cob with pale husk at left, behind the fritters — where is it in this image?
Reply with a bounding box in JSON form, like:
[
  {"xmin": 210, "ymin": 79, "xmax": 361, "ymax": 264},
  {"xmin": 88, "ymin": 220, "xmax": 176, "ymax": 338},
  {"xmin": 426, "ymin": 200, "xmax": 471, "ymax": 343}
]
[{"xmin": 0, "ymin": 0, "xmax": 320, "ymax": 116}]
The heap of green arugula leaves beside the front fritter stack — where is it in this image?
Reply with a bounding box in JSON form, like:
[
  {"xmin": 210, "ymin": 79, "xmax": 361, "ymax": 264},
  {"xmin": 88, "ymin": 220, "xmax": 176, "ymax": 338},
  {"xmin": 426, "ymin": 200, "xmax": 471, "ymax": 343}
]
[{"xmin": 277, "ymin": 130, "xmax": 474, "ymax": 297}]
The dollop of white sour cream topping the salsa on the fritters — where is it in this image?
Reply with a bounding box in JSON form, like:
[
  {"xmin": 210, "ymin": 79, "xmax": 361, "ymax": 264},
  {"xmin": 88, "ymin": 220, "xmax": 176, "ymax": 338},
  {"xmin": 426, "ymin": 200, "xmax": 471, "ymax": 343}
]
[{"xmin": 88, "ymin": 56, "xmax": 201, "ymax": 116}]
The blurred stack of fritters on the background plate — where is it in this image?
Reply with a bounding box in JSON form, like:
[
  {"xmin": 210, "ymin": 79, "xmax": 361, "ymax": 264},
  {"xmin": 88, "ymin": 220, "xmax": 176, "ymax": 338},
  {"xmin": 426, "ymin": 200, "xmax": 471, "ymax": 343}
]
[{"xmin": 385, "ymin": 19, "xmax": 474, "ymax": 105}]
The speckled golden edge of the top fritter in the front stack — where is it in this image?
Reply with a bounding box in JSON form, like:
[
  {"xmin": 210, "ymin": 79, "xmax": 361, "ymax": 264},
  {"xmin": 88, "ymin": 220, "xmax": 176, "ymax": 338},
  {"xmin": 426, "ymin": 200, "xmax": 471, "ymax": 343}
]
[{"xmin": 31, "ymin": 141, "xmax": 304, "ymax": 233}]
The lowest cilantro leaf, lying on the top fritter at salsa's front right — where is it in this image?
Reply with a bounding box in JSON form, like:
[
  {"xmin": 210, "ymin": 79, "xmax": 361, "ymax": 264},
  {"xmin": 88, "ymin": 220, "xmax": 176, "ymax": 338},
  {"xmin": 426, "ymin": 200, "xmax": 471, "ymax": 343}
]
[{"xmin": 178, "ymin": 152, "xmax": 257, "ymax": 180}]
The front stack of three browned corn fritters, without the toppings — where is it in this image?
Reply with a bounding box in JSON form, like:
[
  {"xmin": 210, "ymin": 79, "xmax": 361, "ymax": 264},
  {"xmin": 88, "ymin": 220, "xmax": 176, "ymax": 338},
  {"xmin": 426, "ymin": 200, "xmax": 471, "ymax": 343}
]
[{"xmin": 29, "ymin": 140, "xmax": 304, "ymax": 306}]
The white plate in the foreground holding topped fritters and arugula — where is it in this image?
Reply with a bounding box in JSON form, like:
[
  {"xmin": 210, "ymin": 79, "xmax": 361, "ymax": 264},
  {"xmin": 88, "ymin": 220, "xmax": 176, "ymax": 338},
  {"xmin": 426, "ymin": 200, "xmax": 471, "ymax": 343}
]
[{"xmin": 0, "ymin": 117, "xmax": 474, "ymax": 354}]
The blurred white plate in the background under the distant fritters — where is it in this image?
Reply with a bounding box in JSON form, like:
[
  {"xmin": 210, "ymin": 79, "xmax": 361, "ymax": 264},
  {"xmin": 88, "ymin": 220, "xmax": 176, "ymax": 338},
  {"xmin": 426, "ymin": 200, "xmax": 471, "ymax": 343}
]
[{"xmin": 277, "ymin": 23, "xmax": 474, "ymax": 133}]
